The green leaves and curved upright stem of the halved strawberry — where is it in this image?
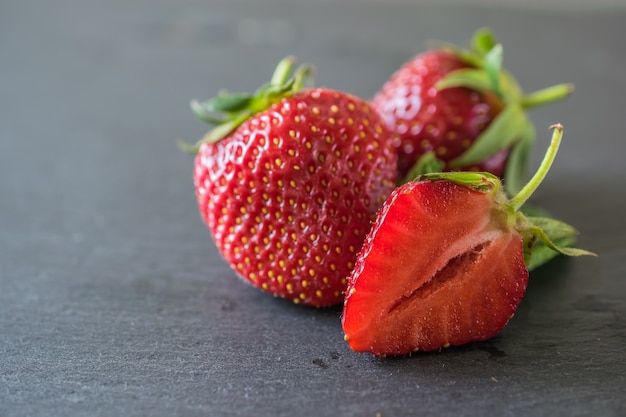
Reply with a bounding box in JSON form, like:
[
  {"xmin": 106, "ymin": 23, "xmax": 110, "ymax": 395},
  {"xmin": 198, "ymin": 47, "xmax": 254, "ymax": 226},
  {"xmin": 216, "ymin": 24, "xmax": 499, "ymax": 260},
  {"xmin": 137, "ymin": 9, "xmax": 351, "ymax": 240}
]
[{"xmin": 417, "ymin": 124, "xmax": 595, "ymax": 270}]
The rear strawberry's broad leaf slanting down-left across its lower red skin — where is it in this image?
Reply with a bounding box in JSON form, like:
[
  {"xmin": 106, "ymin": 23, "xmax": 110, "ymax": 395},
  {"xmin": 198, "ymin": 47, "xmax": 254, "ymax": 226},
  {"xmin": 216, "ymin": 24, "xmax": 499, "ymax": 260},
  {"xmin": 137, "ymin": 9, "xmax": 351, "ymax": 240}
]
[{"xmin": 450, "ymin": 103, "xmax": 530, "ymax": 167}]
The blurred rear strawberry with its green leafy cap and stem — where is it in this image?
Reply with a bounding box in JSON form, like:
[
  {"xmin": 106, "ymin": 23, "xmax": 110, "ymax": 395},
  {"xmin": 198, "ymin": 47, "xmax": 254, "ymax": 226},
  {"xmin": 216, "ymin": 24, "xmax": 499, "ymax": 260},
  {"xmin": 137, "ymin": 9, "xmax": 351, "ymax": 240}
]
[{"xmin": 371, "ymin": 29, "xmax": 573, "ymax": 194}]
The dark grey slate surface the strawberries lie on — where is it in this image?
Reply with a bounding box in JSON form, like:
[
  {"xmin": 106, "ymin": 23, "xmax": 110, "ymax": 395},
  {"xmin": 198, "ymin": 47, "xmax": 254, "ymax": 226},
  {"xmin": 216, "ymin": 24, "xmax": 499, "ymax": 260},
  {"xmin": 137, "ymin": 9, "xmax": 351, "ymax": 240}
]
[{"xmin": 0, "ymin": 0, "xmax": 626, "ymax": 417}]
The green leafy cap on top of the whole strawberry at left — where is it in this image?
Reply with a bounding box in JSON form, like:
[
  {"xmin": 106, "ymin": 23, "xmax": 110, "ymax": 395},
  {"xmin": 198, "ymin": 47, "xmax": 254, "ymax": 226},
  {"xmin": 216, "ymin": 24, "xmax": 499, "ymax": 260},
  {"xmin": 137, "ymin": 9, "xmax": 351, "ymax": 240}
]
[{"xmin": 178, "ymin": 56, "xmax": 313, "ymax": 154}]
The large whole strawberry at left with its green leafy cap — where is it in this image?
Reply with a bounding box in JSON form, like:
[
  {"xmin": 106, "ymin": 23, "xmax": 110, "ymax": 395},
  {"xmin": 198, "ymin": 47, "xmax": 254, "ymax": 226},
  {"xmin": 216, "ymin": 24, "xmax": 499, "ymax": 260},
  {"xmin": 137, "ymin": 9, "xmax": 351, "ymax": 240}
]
[{"xmin": 180, "ymin": 58, "xmax": 397, "ymax": 306}]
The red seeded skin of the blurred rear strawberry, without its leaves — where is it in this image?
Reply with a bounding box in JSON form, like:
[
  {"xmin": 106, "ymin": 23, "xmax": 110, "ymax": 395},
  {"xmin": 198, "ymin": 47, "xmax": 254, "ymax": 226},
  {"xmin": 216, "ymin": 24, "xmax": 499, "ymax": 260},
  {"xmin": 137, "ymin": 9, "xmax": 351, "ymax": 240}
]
[{"xmin": 371, "ymin": 50, "xmax": 508, "ymax": 177}]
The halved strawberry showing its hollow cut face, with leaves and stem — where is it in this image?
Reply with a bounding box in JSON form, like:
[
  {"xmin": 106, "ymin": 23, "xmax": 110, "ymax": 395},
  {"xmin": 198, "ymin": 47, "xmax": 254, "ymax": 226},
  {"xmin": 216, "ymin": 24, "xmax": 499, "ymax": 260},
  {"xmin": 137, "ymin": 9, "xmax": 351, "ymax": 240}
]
[{"xmin": 342, "ymin": 125, "xmax": 591, "ymax": 356}]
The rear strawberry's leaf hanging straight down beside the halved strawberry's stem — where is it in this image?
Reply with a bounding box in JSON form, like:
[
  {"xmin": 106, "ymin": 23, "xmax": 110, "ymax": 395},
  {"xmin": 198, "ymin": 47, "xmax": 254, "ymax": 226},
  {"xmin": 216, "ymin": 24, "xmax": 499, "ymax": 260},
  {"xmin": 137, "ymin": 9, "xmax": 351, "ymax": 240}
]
[{"xmin": 504, "ymin": 123, "xmax": 535, "ymax": 197}]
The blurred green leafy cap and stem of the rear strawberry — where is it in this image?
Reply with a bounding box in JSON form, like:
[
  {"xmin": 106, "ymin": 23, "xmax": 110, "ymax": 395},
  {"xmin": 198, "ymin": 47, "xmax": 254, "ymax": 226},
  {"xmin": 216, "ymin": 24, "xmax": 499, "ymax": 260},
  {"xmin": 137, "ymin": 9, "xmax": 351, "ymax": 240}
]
[{"xmin": 424, "ymin": 28, "xmax": 574, "ymax": 195}]
